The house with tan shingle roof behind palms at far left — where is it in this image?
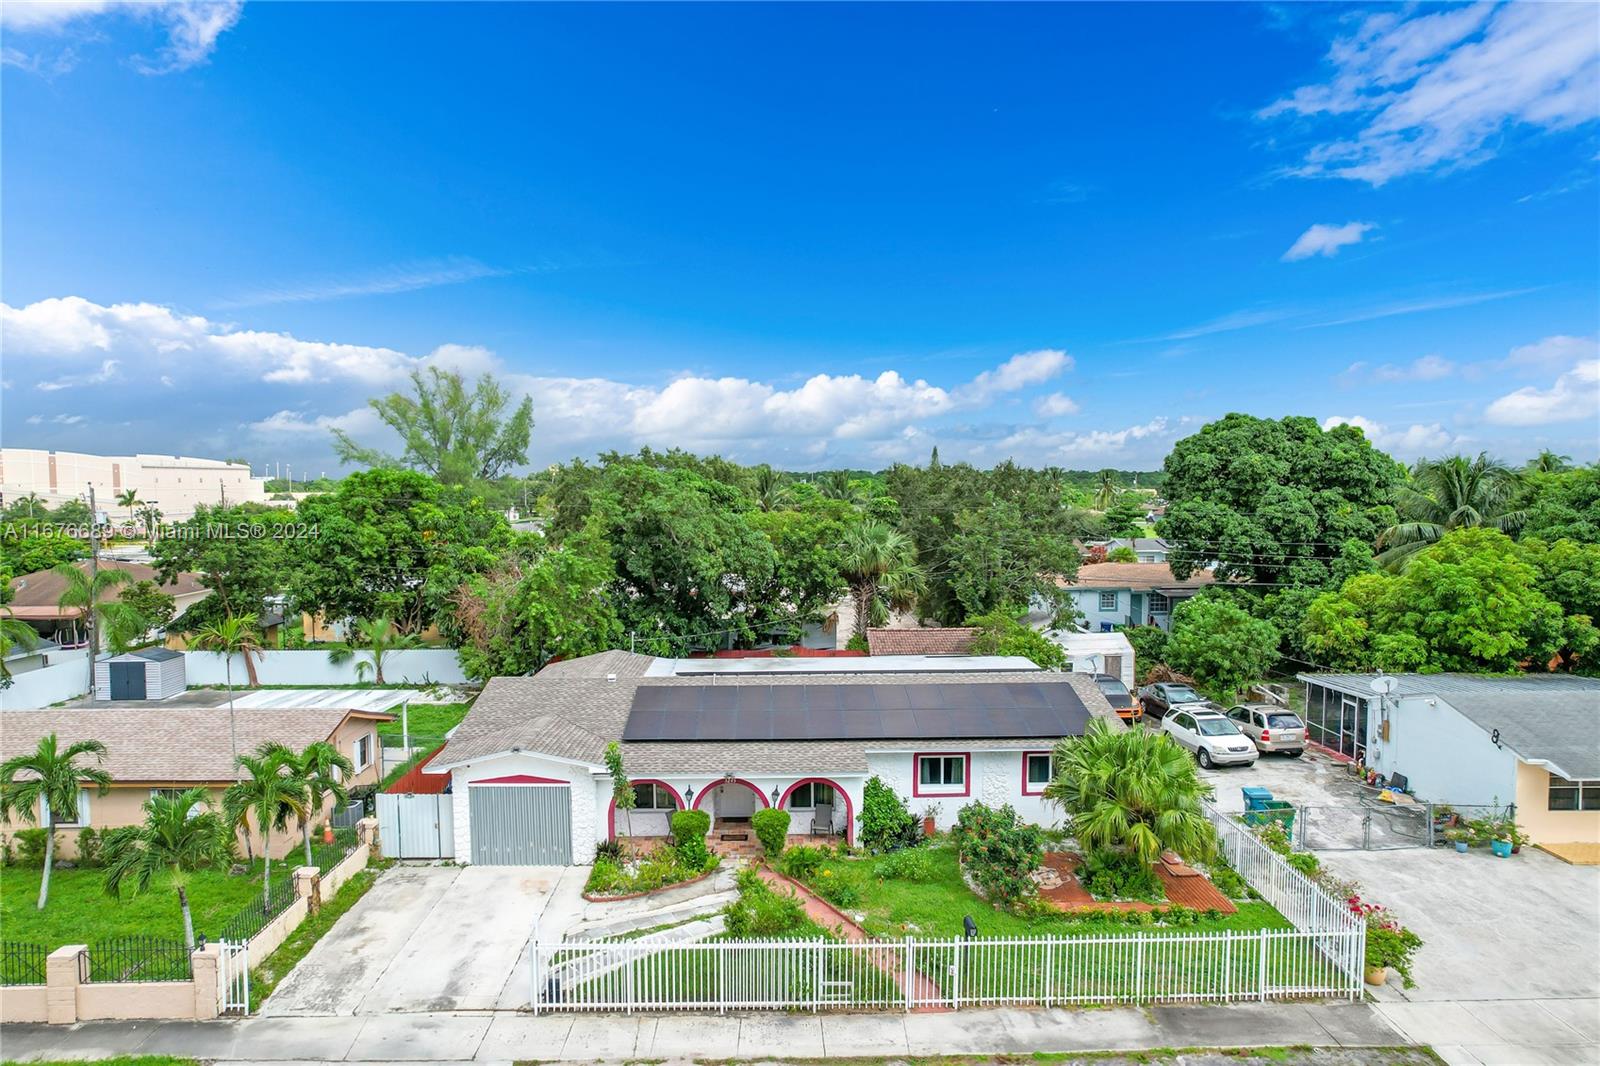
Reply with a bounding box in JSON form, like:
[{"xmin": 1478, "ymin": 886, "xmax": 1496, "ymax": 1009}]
[{"xmin": 0, "ymin": 706, "xmax": 394, "ymax": 858}]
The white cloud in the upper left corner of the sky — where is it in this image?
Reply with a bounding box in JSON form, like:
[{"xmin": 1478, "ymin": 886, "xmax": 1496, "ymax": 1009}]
[{"xmin": 0, "ymin": 0, "xmax": 245, "ymax": 74}]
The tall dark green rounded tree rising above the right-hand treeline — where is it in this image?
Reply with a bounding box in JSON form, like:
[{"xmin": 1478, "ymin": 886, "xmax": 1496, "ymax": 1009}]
[{"xmin": 1158, "ymin": 415, "xmax": 1400, "ymax": 587}]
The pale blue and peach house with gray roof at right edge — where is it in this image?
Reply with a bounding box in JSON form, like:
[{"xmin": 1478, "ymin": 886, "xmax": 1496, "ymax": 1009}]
[{"xmin": 1299, "ymin": 674, "xmax": 1600, "ymax": 844}]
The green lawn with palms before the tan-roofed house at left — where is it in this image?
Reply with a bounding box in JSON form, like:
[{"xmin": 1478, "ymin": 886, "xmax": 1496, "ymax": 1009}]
[{"xmin": 0, "ymin": 844, "xmax": 356, "ymax": 949}]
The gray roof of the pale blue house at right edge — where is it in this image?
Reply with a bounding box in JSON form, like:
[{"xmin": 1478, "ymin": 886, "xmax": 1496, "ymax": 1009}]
[{"xmin": 1299, "ymin": 674, "xmax": 1600, "ymax": 781}]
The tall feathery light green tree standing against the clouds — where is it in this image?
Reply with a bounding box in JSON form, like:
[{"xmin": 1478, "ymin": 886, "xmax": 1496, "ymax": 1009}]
[{"xmin": 333, "ymin": 367, "xmax": 533, "ymax": 485}]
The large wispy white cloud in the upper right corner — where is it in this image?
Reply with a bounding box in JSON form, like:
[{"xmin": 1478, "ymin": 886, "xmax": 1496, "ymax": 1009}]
[{"xmin": 1259, "ymin": 3, "xmax": 1600, "ymax": 186}]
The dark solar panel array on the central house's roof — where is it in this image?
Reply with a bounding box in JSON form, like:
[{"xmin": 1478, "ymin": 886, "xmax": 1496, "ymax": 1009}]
[{"xmin": 622, "ymin": 682, "xmax": 1090, "ymax": 741}]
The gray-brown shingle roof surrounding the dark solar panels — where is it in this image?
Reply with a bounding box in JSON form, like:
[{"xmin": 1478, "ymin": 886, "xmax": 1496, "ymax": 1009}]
[{"xmin": 430, "ymin": 651, "xmax": 1118, "ymax": 775}]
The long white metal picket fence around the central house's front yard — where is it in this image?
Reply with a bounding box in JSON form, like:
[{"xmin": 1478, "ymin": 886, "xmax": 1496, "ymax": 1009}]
[{"xmin": 530, "ymin": 805, "xmax": 1366, "ymax": 1013}]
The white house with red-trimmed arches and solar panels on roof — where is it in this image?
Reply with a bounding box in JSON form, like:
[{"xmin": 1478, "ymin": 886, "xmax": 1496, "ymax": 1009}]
[{"xmin": 426, "ymin": 651, "xmax": 1120, "ymax": 864}]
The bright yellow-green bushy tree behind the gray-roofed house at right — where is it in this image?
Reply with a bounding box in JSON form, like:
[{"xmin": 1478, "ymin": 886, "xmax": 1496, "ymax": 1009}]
[{"xmin": 1304, "ymin": 528, "xmax": 1600, "ymax": 672}]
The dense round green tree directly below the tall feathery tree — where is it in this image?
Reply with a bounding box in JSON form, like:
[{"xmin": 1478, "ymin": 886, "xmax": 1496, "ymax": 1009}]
[{"xmin": 285, "ymin": 469, "xmax": 514, "ymax": 632}]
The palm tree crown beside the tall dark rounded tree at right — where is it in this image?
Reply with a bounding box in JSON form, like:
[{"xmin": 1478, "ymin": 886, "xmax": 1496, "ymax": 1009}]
[{"xmin": 1378, "ymin": 451, "xmax": 1528, "ymax": 571}]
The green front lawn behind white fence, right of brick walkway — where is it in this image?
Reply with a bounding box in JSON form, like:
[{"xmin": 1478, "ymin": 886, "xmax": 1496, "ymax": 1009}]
[{"xmin": 813, "ymin": 844, "xmax": 1290, "ymax": 940}]
